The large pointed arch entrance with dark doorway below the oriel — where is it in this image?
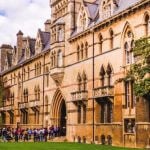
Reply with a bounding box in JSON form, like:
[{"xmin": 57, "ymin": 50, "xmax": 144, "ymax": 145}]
[{"xmin": 51, "ymin": 89, "xmax": 67, "ymax": 136}]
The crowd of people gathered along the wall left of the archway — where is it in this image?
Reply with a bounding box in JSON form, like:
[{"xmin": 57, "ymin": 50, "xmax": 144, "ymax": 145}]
[{"xmin": 0, "ymin": 125, "xmax": 64, "ymax": 142}]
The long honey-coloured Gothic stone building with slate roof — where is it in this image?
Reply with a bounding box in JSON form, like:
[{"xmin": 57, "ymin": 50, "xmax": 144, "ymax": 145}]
[{"xmin": 0, "ymin": 0, "xmax": 150, "ymax": 147}]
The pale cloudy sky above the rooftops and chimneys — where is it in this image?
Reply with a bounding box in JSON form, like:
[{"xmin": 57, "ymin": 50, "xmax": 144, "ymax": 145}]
[{"xmin": 0, "ymin": 0, "xmax": 50, "ymax": 46}]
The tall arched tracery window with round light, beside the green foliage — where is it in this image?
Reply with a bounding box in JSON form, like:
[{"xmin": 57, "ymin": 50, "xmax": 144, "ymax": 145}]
[{"xmin": 124, "ymin": 30, "xmax": 134, "ymax": 64}]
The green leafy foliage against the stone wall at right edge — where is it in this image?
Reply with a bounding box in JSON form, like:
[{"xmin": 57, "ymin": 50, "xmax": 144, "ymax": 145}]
[{"xmin": 125, "ymin": 37, "xmax": 150, "ymax": 98}]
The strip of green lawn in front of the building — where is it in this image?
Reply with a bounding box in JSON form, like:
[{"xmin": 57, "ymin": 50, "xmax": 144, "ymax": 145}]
[{"xmin": 0, "ymin": 143, "xmax": 142, "ymax": 150}]
